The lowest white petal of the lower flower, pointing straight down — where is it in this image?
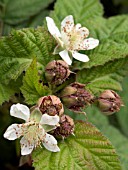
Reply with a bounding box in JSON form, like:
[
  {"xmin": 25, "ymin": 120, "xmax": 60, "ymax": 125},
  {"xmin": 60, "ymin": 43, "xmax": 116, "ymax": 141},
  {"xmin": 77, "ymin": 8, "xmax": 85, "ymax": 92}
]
[{"xmin": 20, "ymin": 137, "xmax": 34, "ymax": 155}]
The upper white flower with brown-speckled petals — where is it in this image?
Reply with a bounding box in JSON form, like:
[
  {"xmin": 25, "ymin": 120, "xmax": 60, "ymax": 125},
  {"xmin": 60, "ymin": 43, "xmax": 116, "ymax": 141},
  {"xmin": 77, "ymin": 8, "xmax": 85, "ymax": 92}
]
[{"xmin": 46, "ymin": 15, "xmax": 99, "ymax": 65}]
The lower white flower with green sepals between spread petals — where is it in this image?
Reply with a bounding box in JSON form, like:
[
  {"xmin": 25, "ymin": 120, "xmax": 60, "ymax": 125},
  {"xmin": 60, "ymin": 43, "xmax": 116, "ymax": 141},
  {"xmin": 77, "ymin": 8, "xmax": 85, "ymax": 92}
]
[{"xmin": 4, "ymin": 103, "xmax": 60, "ymax": 155}]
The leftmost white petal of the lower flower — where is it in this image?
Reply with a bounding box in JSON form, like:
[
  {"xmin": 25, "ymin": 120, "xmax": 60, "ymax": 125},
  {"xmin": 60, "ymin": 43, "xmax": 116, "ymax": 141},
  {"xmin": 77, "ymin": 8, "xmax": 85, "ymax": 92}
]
[{"xmin": 4, "ymin": 124, "xmax": 22, "ymax": 140}]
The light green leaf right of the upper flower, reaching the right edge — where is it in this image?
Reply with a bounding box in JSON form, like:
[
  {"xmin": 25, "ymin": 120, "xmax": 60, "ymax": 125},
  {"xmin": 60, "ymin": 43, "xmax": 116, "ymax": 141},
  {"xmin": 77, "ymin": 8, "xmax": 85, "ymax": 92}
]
[{"xmin": 74, "ymin": 15, "xmax": 128, "ymax": 69}]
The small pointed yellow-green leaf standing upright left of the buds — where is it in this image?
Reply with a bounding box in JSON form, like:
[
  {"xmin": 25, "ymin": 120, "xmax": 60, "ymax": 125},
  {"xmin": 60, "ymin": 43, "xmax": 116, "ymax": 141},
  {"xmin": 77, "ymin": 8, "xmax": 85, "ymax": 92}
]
[{"xmin": 21, "ymin": 59, "xmax": 51, "ymax": 104}]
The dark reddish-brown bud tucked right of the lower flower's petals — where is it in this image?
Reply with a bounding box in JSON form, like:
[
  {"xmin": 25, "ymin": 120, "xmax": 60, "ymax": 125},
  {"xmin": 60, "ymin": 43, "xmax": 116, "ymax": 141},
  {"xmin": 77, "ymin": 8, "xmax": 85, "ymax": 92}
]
[{"xmin": 53, "ymin": 115, "xmax": 74, "ymax": 138}]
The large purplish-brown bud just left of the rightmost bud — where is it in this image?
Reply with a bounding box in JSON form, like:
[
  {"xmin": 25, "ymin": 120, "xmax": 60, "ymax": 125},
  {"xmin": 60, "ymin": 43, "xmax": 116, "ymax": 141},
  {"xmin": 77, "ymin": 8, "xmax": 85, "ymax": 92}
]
[{"xmin": 61, "ymin": 82, "xmax": 93, "ymax": 111}]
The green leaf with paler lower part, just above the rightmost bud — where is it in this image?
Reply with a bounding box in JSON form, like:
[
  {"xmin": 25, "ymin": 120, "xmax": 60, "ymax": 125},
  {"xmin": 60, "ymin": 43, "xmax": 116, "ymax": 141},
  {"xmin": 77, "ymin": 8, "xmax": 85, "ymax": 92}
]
[{"xmin": 77, "ymin": 57, "xmax": 128, "ymax": 94}]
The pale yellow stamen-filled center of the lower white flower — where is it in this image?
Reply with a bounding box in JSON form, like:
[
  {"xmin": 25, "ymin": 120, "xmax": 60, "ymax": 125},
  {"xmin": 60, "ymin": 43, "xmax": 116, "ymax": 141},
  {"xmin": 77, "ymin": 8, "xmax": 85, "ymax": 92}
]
[{"xmin": 23, "ymin": 122, "xmax": 45, "ymax": 147}]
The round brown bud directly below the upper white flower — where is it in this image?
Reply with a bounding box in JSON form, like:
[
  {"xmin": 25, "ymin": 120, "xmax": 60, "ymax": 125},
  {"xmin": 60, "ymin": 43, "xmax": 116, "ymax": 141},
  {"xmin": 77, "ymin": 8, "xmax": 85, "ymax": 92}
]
[{"xmin": 45, "ymin": 60, "xmax": 71, "ymax": 85}]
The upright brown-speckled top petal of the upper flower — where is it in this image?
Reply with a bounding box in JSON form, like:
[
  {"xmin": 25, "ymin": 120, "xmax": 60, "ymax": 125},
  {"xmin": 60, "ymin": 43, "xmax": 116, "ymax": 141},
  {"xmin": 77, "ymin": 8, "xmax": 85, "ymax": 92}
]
[{"xmin": 61, "ymin": 15, "xmax": 74, "ymax": 33}]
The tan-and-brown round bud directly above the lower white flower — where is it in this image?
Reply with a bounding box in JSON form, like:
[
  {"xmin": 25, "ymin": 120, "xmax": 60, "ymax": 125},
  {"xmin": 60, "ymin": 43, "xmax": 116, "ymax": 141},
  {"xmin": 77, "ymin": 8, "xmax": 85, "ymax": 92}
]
[{"xmin": 37, "ymin": 95, "xmax": 64, "ymax": 116}]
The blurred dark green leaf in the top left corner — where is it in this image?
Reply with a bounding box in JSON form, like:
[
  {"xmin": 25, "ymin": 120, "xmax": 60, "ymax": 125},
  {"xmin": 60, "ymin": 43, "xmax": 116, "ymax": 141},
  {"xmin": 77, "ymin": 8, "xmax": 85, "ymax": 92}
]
[{"xmin": 0, "ymin": 0, "xmax": 54, "ymax": 35}]
